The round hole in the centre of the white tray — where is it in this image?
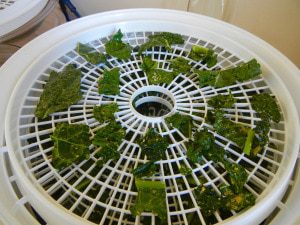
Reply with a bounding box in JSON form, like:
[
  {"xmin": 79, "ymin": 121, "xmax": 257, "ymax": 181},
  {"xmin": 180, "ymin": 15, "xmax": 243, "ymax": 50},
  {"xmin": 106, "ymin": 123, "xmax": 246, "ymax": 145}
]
[{"xmin": 132, "ymin": 88, "xmax": 174, "ymax": 117}]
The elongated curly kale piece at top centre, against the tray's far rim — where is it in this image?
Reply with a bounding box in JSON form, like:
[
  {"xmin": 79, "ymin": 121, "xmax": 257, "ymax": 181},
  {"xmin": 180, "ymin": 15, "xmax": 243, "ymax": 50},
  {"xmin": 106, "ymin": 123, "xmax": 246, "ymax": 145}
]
[{"xmin": 138, "ymin": 32, "xmax": 184, "ymax": 54}]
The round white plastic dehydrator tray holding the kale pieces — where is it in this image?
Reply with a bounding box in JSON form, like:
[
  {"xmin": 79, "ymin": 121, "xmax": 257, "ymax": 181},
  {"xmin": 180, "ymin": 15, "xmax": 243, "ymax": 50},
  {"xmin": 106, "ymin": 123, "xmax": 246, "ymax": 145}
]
[{"xmin": 0, "ymin": 9, "xmax": 299, "ymax": 224}]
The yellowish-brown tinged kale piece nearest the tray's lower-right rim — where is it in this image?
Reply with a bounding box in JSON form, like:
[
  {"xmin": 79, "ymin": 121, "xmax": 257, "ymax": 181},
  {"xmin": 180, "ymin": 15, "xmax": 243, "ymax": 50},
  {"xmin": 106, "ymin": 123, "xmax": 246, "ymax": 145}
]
[{"xmin": 219, "ymin": 185, "xmax": 255, "ymax": 212}]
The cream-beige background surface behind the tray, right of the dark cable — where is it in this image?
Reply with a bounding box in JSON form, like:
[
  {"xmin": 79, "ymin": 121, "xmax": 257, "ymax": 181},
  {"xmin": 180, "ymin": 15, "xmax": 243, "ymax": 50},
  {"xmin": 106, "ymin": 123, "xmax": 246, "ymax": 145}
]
[{"xmin": 71, "ymin": 0, "xmax": 300, "ymax": 68}]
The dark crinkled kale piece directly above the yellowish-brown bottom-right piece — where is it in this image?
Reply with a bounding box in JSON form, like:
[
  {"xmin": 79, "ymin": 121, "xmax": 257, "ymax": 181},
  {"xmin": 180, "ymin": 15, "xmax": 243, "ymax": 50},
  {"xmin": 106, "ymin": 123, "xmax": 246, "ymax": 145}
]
[{"xmin": 224, "ymin": 161, "xmax": 248, "ymax": 193}]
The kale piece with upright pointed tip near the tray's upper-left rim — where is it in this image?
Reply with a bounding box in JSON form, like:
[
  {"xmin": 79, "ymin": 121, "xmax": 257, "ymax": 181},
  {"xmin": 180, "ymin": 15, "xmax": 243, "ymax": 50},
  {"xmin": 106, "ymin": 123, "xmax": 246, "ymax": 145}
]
[{"xmin": 105, "ymin": 30, "xmax": 132, "ymax": 60}]
